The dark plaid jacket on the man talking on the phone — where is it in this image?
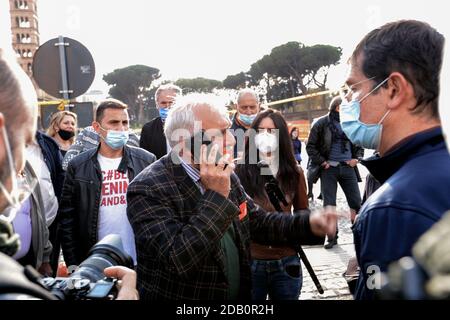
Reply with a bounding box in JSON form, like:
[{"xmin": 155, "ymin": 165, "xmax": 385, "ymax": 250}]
[{"xmin": 127, "ymin": 153, "xmax": 323, "ymax": 300}]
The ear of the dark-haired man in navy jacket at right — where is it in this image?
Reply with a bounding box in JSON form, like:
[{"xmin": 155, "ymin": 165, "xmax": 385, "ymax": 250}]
[{"xmin": 387, "ymin": 72, "xmax": 414, "ymax": 109}]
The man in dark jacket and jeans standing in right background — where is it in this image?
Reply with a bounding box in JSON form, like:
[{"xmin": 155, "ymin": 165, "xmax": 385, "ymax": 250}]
[{"xmin": 306, "ymin": 97, "xmax": 364, "ymax": 249}]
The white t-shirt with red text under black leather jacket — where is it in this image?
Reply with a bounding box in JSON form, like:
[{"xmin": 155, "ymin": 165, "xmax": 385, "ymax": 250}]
[{"xmin": 98, "ymin": 154, "xmax": 136, "ymax": 265}]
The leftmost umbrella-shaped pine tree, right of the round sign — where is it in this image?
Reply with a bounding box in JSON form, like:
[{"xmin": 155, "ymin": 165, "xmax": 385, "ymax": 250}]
[{"xmin": 103, "ymin": 65, "xmax": 161, "ymax": 124}]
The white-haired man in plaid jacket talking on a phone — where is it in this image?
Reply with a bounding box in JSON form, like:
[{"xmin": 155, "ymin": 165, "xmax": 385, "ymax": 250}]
[{"xmin": 128, "ymin": 95, "xmax": 336, "ymax": 300}]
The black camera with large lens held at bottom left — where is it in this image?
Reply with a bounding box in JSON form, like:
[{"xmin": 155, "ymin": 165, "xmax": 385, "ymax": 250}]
[{"xmin": 40, "ymin": 234, "xmax": 133, "ymax": 300}]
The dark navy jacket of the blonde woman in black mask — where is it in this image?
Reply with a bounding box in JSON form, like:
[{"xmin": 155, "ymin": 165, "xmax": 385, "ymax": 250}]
[{"xmin": 36, "ymin": 131, "xmax": 64, "ymax": 201}]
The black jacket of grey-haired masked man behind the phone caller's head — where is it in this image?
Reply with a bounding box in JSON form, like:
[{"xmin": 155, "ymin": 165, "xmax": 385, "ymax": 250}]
[{"xmin": 139, "ymin": 117, "xmax": 167, "ymax": 159}]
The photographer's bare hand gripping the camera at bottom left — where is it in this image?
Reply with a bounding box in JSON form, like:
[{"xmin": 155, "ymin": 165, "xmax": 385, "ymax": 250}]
[{"xmin": 104, "ymin": 266, "xmax": 139, "ymax": 300}]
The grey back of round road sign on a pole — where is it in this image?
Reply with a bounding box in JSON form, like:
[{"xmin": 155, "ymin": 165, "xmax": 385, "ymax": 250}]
[{"xmin": 33, "ymin": 36, "xmax": 95, "ymax": 99}]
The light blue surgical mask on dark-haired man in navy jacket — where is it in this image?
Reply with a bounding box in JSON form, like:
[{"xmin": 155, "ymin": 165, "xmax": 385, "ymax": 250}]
[{"xmin": 339, "ymin": 77, "xmax": 390, "ymax": 149}]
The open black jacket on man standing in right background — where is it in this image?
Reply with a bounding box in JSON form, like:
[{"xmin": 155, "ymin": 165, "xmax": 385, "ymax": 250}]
[{"xmin": 306, "ymin": 114, "xmax": 364, "ymax": 182}]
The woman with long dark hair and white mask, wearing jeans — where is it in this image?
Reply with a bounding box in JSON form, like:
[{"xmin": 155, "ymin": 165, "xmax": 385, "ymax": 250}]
[{"xmin": 236, "ymin": 109, "xmax": 308, "ymax": 300}]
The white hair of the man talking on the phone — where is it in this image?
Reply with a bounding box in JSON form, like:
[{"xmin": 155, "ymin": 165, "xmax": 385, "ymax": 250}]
[{"xmin": 164, "ymin": 93, "xmax": 228, "ymax": 148}]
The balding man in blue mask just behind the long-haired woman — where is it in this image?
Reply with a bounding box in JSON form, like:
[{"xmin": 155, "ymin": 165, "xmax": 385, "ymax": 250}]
[{"xmin": 231, "ymin": 88, "xmax": 261, "ymax": 158}]
